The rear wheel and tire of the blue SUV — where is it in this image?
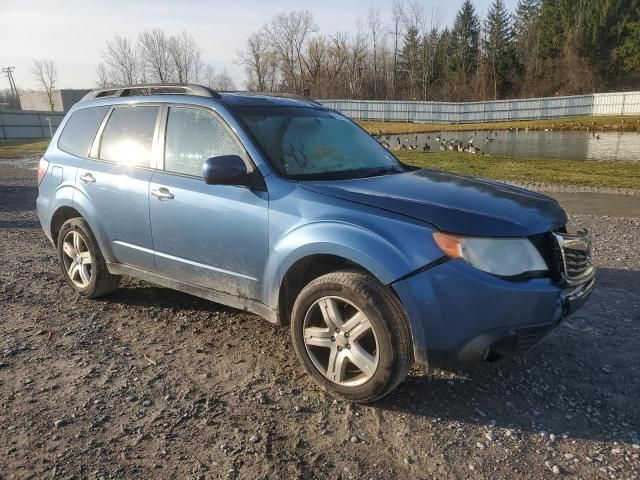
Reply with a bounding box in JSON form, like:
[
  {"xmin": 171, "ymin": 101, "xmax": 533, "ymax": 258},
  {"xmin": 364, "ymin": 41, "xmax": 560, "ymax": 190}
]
[{"xmin": 57, "ymin": 217, "xmax": 120, "ymax": 298}]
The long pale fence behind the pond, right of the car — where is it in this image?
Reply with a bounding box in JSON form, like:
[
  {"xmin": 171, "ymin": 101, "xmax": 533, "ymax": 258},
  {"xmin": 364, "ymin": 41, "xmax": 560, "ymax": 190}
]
[{"xmin": 320, "ymin": 92, "xmax": 640, "ymax": 123}]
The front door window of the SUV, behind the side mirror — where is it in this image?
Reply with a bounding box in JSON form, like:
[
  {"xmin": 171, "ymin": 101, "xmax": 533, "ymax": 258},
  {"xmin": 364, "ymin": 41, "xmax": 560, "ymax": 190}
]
[{"xmin": 164, "ymin": 107, "xmax": 244, "ymax": 177}]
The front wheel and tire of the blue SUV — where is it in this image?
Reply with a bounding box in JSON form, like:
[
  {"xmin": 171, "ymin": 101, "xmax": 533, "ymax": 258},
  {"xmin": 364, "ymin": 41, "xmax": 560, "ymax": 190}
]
[{"xmin": 291, "ymin": 270, "xmax": 412, "ymax": 403}]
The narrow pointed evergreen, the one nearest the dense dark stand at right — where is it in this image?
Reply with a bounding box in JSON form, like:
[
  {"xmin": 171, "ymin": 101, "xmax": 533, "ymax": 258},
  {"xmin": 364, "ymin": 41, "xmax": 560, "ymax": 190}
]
[{"xmin": 484, "ymin": 0, "xmax": 515, "ymax": 99}]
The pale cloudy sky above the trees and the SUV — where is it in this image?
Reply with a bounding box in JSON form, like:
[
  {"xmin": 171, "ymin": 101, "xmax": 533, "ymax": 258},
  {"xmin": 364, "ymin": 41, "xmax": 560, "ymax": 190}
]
[{"xmin": 0, "ymin": 0, "xmax": 517, "ymax": 92}]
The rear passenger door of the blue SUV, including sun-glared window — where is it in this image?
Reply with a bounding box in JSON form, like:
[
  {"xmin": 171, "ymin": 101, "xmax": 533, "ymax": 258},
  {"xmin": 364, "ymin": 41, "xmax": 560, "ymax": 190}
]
[{"xmin": 76, "ymin": 104, "xmax": 160, "ymax": 271}]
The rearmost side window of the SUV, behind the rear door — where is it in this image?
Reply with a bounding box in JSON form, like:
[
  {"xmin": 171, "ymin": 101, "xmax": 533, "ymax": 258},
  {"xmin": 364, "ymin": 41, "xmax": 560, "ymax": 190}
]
[{"xmin": 58, "ymin": 107, "xmax": 109, "ymax": 157}]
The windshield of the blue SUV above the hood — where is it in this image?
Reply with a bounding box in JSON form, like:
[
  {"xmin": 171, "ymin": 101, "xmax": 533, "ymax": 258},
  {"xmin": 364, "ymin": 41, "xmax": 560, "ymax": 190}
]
[{"xmin": 236, "ymin": 107, "xmax": 404, "ymax": 179}]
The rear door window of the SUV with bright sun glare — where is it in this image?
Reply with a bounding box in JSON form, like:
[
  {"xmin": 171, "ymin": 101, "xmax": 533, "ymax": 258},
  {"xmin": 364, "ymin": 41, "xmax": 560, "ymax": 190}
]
[{"xmin": 98, "ymin": 105, "xmax": 160, "ymax": 167}]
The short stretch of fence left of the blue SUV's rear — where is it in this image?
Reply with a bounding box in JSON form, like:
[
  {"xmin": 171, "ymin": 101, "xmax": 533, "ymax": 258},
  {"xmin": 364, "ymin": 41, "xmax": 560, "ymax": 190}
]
[{"xmin": 0, "ymin": 110, "xmax": 64, "ymax": 140}]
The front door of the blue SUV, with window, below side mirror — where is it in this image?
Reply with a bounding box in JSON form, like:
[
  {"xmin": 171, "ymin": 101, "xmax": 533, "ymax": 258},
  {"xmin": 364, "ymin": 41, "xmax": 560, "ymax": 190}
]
[{"xmin": 149, "ymin": 105, "xmax": 268, "ymax": 299}]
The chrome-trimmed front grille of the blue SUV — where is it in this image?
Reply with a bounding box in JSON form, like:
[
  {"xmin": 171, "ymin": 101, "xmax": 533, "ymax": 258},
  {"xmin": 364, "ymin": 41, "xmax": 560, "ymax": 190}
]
[{"xmin": 553, "ymin": 232, "xmax": 594, "ymax": 285}]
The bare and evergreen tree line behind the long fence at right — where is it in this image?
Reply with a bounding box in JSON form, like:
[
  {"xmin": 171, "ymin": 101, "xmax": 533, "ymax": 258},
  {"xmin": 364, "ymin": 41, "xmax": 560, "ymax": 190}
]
[{"xmin": 238, "ymin": 0, "xmax": 640, "ymax": 101}]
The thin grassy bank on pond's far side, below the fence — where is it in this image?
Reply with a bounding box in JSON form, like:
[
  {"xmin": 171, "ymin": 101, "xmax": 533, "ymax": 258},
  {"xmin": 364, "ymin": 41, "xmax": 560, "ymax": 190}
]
[{"xmin": 359, "ymin": 115, "xmax": 640, "ymax": 135}]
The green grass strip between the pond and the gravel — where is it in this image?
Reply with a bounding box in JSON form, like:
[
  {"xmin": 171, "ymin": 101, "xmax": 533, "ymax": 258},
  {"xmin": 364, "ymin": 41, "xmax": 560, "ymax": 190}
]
[{"xmin": 396, "ymin": 152, "xmax": 640, "ymax": 190}]
